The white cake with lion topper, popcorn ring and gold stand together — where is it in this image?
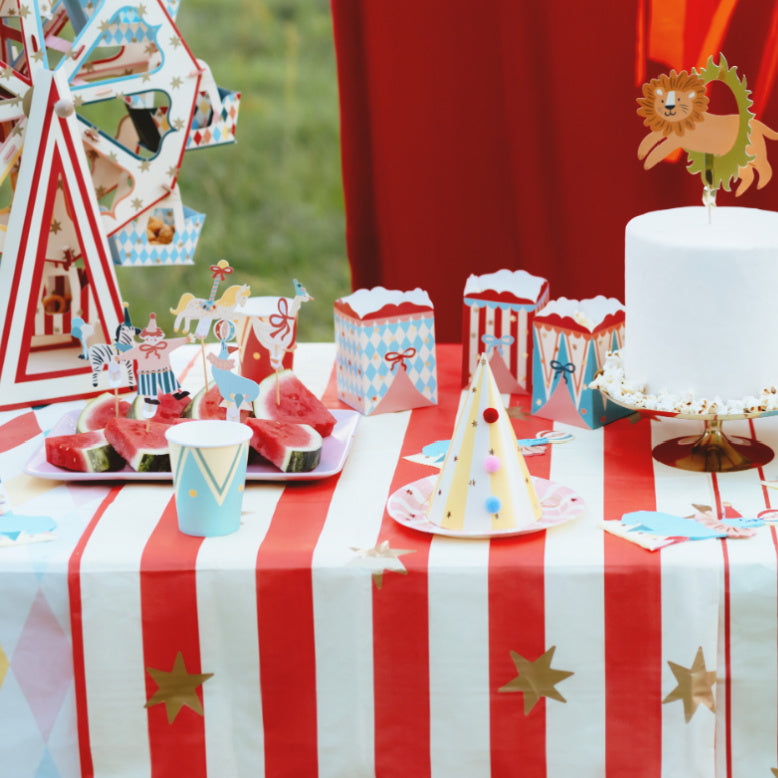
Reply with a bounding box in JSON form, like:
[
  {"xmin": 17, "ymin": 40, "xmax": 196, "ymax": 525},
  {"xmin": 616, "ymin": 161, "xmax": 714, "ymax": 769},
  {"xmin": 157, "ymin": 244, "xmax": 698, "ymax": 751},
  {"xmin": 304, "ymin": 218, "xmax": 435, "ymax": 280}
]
[{"xmin": 592, "ymin": 55, "xmax": 778, "ymax": 472}]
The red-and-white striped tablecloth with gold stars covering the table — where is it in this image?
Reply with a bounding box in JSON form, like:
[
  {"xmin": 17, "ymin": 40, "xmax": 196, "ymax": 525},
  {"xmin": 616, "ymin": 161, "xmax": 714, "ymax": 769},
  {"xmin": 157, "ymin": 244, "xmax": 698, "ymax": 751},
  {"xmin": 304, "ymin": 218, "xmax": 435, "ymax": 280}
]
[{"xmin": 0, "ymin": 344, "xmax": 778, "ymax": 778}]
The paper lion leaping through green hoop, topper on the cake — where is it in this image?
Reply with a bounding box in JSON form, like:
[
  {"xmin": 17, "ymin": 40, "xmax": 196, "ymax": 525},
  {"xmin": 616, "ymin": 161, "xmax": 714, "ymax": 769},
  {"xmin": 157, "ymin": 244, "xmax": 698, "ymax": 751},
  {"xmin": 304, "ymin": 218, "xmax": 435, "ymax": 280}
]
[{"xmin": 637, "ymin": 54, "xmax": 778, "ymax": 221}]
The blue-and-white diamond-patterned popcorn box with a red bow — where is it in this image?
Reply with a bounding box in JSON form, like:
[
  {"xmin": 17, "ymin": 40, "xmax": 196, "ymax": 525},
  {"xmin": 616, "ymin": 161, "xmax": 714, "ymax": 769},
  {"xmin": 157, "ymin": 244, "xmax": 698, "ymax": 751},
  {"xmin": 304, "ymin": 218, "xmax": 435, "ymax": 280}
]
[{"xmin": 335, "ymin": 286, "xmax": 438, "ymax": 415}]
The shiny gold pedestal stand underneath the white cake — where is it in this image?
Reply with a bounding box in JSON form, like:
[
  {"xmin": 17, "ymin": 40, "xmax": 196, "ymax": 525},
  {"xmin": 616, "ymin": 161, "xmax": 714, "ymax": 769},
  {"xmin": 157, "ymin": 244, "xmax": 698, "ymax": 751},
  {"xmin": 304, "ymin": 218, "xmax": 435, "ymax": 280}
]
[{"xmin": 599, "ymin": 388, "xmax": 778, "ymax": 473}]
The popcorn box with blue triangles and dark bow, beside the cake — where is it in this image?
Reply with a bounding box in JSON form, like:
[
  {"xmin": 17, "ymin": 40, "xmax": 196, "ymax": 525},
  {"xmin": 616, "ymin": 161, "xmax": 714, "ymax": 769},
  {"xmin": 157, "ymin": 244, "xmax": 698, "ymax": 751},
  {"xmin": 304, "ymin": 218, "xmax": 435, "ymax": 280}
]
[{"xmin": 532, "ymin": 295, "xmax": 632, "ymax": 429}]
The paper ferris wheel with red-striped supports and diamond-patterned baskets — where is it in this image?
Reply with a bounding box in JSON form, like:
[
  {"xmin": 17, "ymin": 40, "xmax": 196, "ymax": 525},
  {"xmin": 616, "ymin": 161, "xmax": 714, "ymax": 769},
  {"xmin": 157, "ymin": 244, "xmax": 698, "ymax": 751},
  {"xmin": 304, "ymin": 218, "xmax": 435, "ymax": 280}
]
[{"xmin": 0, "ymin": 0, "xmax": 240, "ymax": 408}]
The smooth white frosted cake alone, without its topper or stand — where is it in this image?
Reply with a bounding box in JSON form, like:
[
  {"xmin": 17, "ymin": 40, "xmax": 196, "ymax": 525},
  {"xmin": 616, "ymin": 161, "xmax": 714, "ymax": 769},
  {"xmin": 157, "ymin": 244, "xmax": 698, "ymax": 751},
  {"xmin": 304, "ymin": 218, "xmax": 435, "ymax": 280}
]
[{"xmin": 622, "ymin": 206, "xmax": 778, "ymax": 399}]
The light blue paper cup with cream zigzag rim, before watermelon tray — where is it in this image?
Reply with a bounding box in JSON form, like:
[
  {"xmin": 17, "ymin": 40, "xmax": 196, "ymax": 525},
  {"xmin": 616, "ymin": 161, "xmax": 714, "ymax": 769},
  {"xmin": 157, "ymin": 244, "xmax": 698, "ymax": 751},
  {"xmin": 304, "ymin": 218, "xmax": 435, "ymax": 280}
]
[{"xmin": 165, "ymin": 420, "xmax": 252, "ymax": 537}]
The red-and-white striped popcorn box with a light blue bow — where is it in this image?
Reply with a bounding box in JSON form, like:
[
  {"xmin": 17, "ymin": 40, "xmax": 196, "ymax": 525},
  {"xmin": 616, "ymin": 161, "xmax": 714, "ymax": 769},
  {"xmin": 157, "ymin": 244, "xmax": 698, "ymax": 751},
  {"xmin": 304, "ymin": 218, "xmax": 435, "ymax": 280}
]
[{"xmin": 462, "ymin": 270, "xmax": 549, "ymax": 394}]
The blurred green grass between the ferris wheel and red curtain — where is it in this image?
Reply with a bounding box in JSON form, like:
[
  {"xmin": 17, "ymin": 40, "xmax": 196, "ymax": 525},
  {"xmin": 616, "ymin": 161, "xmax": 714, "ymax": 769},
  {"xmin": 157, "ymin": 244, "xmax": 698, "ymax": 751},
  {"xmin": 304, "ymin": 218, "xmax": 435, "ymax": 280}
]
[{"xmin": 117, "ymin": 0, "xmax": 350, "ymax": 341}]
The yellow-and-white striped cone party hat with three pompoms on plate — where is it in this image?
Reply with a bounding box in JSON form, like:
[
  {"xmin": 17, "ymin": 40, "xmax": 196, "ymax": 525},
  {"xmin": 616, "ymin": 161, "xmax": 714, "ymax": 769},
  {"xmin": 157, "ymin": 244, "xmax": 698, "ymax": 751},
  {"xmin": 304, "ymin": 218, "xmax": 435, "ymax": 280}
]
[{"xmin": 427, "ymin": 355, "xmax": 543, "ymax": 534}]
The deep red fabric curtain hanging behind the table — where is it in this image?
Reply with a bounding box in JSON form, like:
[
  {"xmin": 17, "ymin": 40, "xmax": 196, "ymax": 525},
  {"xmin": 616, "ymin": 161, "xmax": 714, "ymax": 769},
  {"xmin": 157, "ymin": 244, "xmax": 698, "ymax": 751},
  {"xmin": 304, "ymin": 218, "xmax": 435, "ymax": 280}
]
[{"xmin": 332, "ymin": 0, "xmax": 778, "ymax": 342}]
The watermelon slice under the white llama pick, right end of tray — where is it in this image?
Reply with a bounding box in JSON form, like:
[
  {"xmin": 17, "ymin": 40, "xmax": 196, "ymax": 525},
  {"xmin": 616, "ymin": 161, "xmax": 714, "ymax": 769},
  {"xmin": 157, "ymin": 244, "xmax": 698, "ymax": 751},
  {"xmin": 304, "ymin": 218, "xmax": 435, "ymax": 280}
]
[{"xmin": 254, "ymin": 370, "xmax": 336, "ymax": 438}]
